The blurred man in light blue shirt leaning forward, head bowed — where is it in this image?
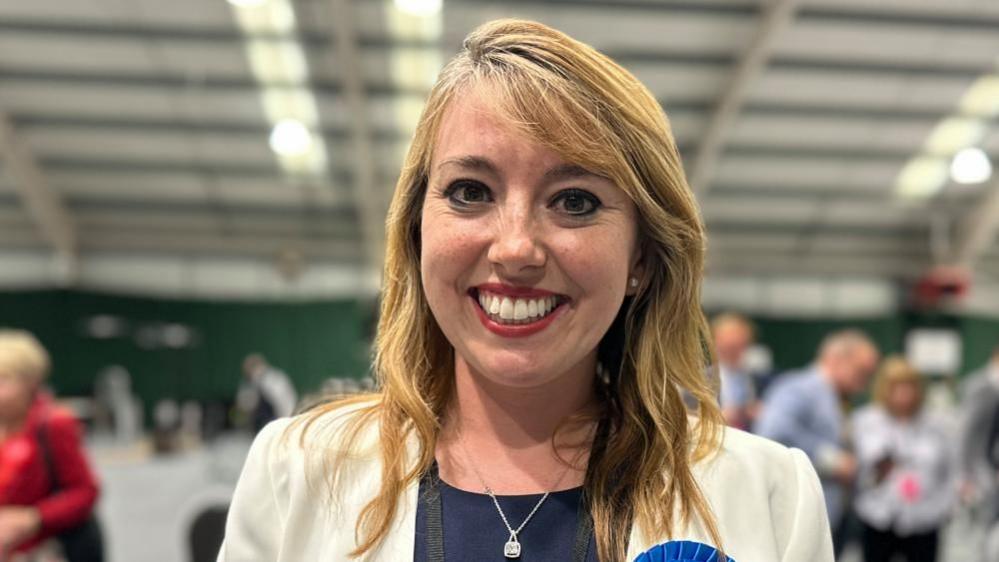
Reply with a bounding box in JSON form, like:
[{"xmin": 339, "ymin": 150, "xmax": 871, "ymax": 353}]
[{"xmin": 754, "ymin": 330, "xmax": 879, "ymax": 553}]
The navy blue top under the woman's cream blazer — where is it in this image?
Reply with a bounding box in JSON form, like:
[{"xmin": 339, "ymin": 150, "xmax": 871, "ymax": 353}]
[{"xmin": 413, "ymin": 470, "xmax": 598, "ymax": 562}]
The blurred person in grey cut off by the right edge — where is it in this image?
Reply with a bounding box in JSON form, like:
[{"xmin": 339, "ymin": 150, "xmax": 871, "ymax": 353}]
[{"xmin": 958, "ymin": 346, "xmax": 999, "ymax": 561}]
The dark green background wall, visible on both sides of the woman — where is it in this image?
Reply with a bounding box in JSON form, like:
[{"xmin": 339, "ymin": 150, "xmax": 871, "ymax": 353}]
[{"xmin": 7, "ymin": 290, "xmax": 999, "ymax": 405}]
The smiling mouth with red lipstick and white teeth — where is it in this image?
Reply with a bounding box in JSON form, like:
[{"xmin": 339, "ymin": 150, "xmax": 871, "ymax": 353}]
[{"xmin": 469, "ymin": 286, "xmax": 569, "ymax": 337}]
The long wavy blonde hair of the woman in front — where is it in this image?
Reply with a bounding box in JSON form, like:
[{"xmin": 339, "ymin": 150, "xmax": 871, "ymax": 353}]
[{"xmin": 292, "ymin": 20, "xmax": 723, "ymax": 562}]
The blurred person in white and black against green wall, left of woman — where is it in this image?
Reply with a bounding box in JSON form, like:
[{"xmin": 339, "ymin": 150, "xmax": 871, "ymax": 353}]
[{"xmin": 236, "ymin": 353, "xmax": 298, "ymax": 433}]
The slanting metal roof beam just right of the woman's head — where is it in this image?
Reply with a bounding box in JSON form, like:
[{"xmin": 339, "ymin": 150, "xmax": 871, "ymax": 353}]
[{"xmin": 690, "ymin": 0, "xmax": 798, "ymax": 195}]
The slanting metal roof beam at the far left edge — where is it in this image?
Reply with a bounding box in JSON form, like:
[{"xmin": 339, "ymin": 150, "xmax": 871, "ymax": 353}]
[{"xmin": 0, "ymin": 111, "xmax": 79, "ymax": 284}]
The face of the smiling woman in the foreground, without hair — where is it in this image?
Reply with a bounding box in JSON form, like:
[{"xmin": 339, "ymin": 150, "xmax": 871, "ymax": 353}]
[{"xmin": 421, "ymin": 96, "xmax": 641, "ymax": 387}]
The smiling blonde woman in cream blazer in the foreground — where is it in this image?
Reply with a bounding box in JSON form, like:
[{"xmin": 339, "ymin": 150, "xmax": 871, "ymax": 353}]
[{"xmin": 219, "ymin": 20, "xmax": 832, "ymax": 562}]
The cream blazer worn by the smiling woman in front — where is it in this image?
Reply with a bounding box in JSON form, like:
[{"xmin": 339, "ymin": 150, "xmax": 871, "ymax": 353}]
[{"xmin": 218, "ymin": 406, "xmax": 833, "ymax": 562}]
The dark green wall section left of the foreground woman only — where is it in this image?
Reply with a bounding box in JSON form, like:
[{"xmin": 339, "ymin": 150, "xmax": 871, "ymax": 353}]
[{"xmin": 0, "ymin": 290, "xmax": 373, "ymax": 405}]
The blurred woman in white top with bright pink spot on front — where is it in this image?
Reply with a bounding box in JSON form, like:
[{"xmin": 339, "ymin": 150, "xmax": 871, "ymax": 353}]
[{"xmin": 850, "ymin": 357, "xmax": 957, "ymax": 562}]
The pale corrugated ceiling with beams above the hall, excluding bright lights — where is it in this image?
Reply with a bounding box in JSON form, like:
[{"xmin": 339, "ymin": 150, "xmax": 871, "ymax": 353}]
[{"xmin": 0, "ymin": 0, "xmax": 999, "ymax": 288}]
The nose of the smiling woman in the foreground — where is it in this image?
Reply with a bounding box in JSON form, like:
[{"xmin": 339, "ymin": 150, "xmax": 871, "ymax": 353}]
[{"xmin": 488, "ymin": 208, "xmax": 547, "ymax": 277}]
